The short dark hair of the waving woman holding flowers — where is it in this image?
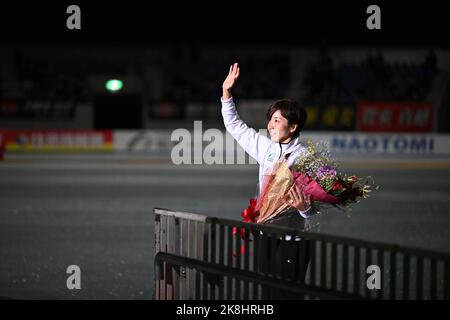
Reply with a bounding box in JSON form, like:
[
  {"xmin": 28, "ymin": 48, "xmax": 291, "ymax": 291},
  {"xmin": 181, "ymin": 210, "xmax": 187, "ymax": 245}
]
[{"xmin": 267, "ymin": 99, "xmax": 307, "ymax": 137}]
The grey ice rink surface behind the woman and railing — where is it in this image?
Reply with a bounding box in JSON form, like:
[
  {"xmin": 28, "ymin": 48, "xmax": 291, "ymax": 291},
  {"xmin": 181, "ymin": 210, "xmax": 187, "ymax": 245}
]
[{"xmin": 0, "ymin": 156, "xmax": 450, "ymax": 299}]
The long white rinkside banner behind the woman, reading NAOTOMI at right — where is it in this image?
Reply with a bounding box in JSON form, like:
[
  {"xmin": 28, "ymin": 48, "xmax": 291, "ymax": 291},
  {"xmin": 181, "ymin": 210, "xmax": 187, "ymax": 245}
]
[{"xmin": 114, "ymin": 129, "xmax": 450, "ymax": 158}]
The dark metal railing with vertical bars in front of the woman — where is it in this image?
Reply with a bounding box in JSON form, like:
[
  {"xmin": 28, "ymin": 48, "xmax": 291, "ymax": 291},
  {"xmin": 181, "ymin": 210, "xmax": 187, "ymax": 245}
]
[{"xmin": 154, "ymin": 209, "xmax": 450, "ymax": 300}]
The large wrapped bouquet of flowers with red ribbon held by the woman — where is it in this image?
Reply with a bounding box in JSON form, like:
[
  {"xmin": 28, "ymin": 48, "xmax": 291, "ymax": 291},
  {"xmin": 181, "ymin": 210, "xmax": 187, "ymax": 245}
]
[{"xmin": 241, "ymin": 141, "xmax": 378, "ymax": 223}]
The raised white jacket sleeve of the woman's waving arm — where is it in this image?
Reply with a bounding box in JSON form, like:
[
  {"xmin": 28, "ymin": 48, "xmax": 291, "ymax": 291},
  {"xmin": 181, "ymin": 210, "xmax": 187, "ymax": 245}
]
[{"xmin": 221, "ymin": 98, "xmax": 271, "ymax": 164}]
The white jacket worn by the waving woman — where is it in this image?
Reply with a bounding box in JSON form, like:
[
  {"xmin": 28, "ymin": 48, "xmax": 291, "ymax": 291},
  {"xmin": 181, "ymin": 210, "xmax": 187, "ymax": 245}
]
[{"xmin": 221, "ymin": 98, "xmax": 314, "ymax": 218}]
